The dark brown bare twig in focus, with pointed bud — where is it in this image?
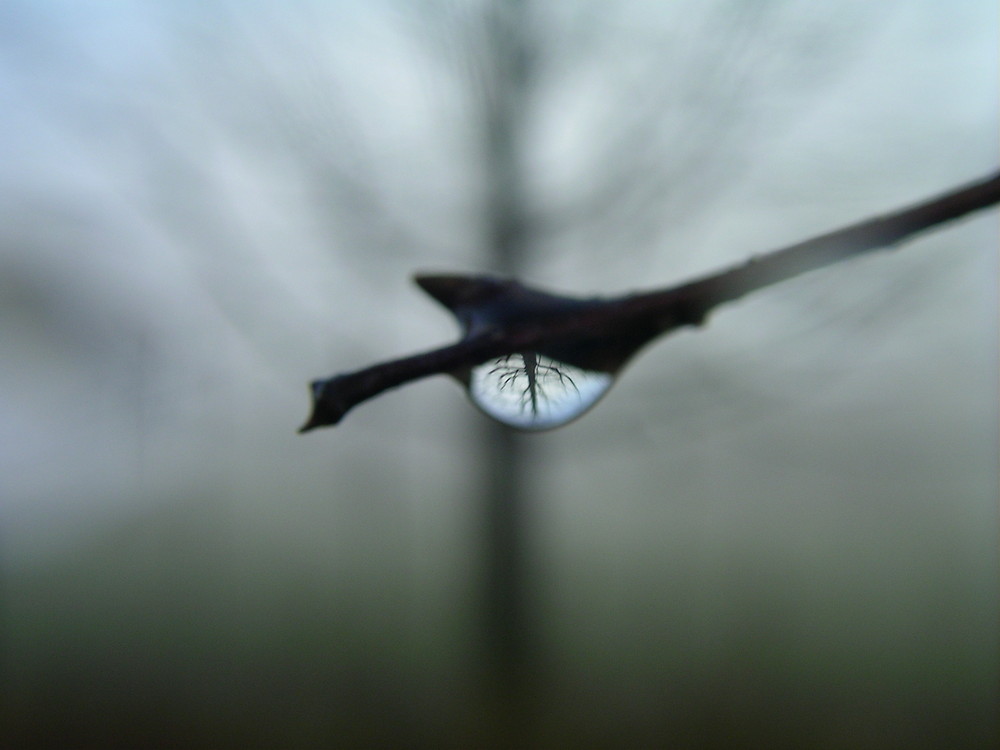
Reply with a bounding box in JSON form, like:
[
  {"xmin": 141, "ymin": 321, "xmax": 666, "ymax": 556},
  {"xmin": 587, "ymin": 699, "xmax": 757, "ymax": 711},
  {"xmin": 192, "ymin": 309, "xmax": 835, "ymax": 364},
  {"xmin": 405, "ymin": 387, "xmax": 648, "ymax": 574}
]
[{"xmin": 299, "ymin": 169, "xmax": 1000, "ymax": 432}]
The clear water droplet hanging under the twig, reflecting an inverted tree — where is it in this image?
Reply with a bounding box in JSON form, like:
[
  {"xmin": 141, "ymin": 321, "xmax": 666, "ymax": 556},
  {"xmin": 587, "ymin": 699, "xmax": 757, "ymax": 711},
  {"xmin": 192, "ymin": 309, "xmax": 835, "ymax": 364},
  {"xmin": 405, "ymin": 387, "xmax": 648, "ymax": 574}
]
[{"xmin": 468, "ymin": 352, "xmax": 614, "ymax": 430}]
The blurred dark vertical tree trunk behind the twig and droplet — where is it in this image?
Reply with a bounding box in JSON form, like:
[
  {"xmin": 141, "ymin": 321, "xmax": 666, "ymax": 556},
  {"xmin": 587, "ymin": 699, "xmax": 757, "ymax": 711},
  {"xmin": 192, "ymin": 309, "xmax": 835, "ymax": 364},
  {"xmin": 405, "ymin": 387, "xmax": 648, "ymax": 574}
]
[{"xmin": 480, "ymin": 0, "xmax": 533, "ymax": 710}]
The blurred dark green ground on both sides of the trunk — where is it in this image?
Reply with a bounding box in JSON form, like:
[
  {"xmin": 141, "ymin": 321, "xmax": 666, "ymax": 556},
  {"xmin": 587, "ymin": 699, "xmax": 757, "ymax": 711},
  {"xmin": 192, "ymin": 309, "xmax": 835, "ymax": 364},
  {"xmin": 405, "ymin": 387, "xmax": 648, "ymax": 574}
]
[{"xmin": 0, "ymin": 470, "xmax": 997, "ymax": 748}]
